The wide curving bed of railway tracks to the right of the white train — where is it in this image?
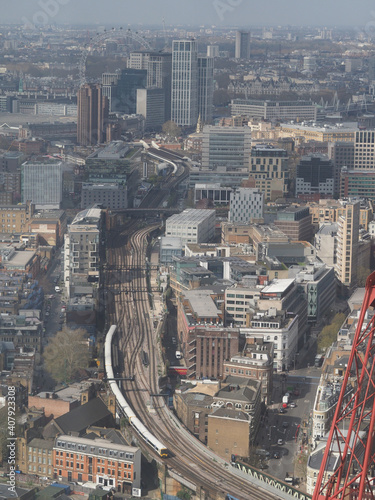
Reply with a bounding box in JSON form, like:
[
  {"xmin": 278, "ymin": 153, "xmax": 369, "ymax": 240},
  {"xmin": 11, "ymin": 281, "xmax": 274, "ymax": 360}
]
[{"xmin": 107, "ymin": 221, "xmax": 279, "ymax": 500}]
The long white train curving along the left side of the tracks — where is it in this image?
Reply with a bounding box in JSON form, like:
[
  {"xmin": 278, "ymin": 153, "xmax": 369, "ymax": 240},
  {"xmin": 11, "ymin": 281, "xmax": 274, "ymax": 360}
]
[{"xmin": 104, "ymin": 325, "xmax": 168, "ymax": 458}]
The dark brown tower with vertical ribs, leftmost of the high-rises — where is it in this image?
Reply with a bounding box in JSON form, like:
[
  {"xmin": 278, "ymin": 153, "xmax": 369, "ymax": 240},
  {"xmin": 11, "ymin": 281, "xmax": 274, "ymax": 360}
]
[{"xmin": 77, "ymin": 83, "xmax": 108, "ymax": 146}]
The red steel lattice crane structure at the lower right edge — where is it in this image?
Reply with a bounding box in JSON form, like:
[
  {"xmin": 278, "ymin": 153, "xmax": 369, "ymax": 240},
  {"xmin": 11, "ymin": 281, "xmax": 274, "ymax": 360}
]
[{"xmin": 312, "ymin": 272, "xmax": 375, "ymax": 500}]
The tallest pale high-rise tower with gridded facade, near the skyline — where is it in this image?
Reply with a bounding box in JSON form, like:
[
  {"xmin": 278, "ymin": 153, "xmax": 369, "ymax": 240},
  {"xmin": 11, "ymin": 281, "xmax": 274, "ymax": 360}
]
[{"xmin": 171, "ymin": 40, "xmax": 198, "ymax": 127}]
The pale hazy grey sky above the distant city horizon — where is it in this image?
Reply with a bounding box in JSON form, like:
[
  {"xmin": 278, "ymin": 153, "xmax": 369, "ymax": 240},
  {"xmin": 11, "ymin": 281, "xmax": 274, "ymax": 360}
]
[{"xmin": 4, "ymin": 0, "xmax": 375, "ymax": 28}]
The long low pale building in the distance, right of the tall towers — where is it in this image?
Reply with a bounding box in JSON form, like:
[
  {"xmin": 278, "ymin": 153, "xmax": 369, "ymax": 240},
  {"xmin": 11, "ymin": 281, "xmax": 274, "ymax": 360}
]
[{"xmin": 231, "ymin": 99, "xmax": 317, "ymax": 121}]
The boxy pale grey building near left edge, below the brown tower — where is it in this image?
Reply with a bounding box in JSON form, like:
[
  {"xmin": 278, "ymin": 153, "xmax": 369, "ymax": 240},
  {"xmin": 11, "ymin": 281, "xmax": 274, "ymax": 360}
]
[{"xmin": 21, "ymin": 158, "xmax": 63, "ymax": 208}]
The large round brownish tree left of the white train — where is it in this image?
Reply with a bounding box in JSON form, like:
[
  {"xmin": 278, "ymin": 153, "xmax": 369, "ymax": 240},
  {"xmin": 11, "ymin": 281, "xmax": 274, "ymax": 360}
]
[{"xmin": 43, "ymin": 327, "xmax": 89, "ymax": 382}]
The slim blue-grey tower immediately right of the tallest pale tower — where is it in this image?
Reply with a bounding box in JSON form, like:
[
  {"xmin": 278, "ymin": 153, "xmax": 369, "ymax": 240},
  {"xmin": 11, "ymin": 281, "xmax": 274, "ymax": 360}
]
[{"xmin": 198, "ymin": 56, "xmax": 214, "ymax": 123}]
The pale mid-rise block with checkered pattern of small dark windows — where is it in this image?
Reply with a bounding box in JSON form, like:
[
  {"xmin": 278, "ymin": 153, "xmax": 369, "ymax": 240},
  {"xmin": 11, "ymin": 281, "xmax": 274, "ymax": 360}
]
[{"xmin": 228, "ymin": 187, "xmax": 264, "ymax": 224}]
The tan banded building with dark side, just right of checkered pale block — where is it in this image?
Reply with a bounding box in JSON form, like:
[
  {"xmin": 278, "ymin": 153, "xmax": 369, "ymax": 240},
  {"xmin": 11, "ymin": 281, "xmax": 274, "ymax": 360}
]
[{"xmin": 275, "ymin": 207, "xmax": 313, "ymax": 241}]
